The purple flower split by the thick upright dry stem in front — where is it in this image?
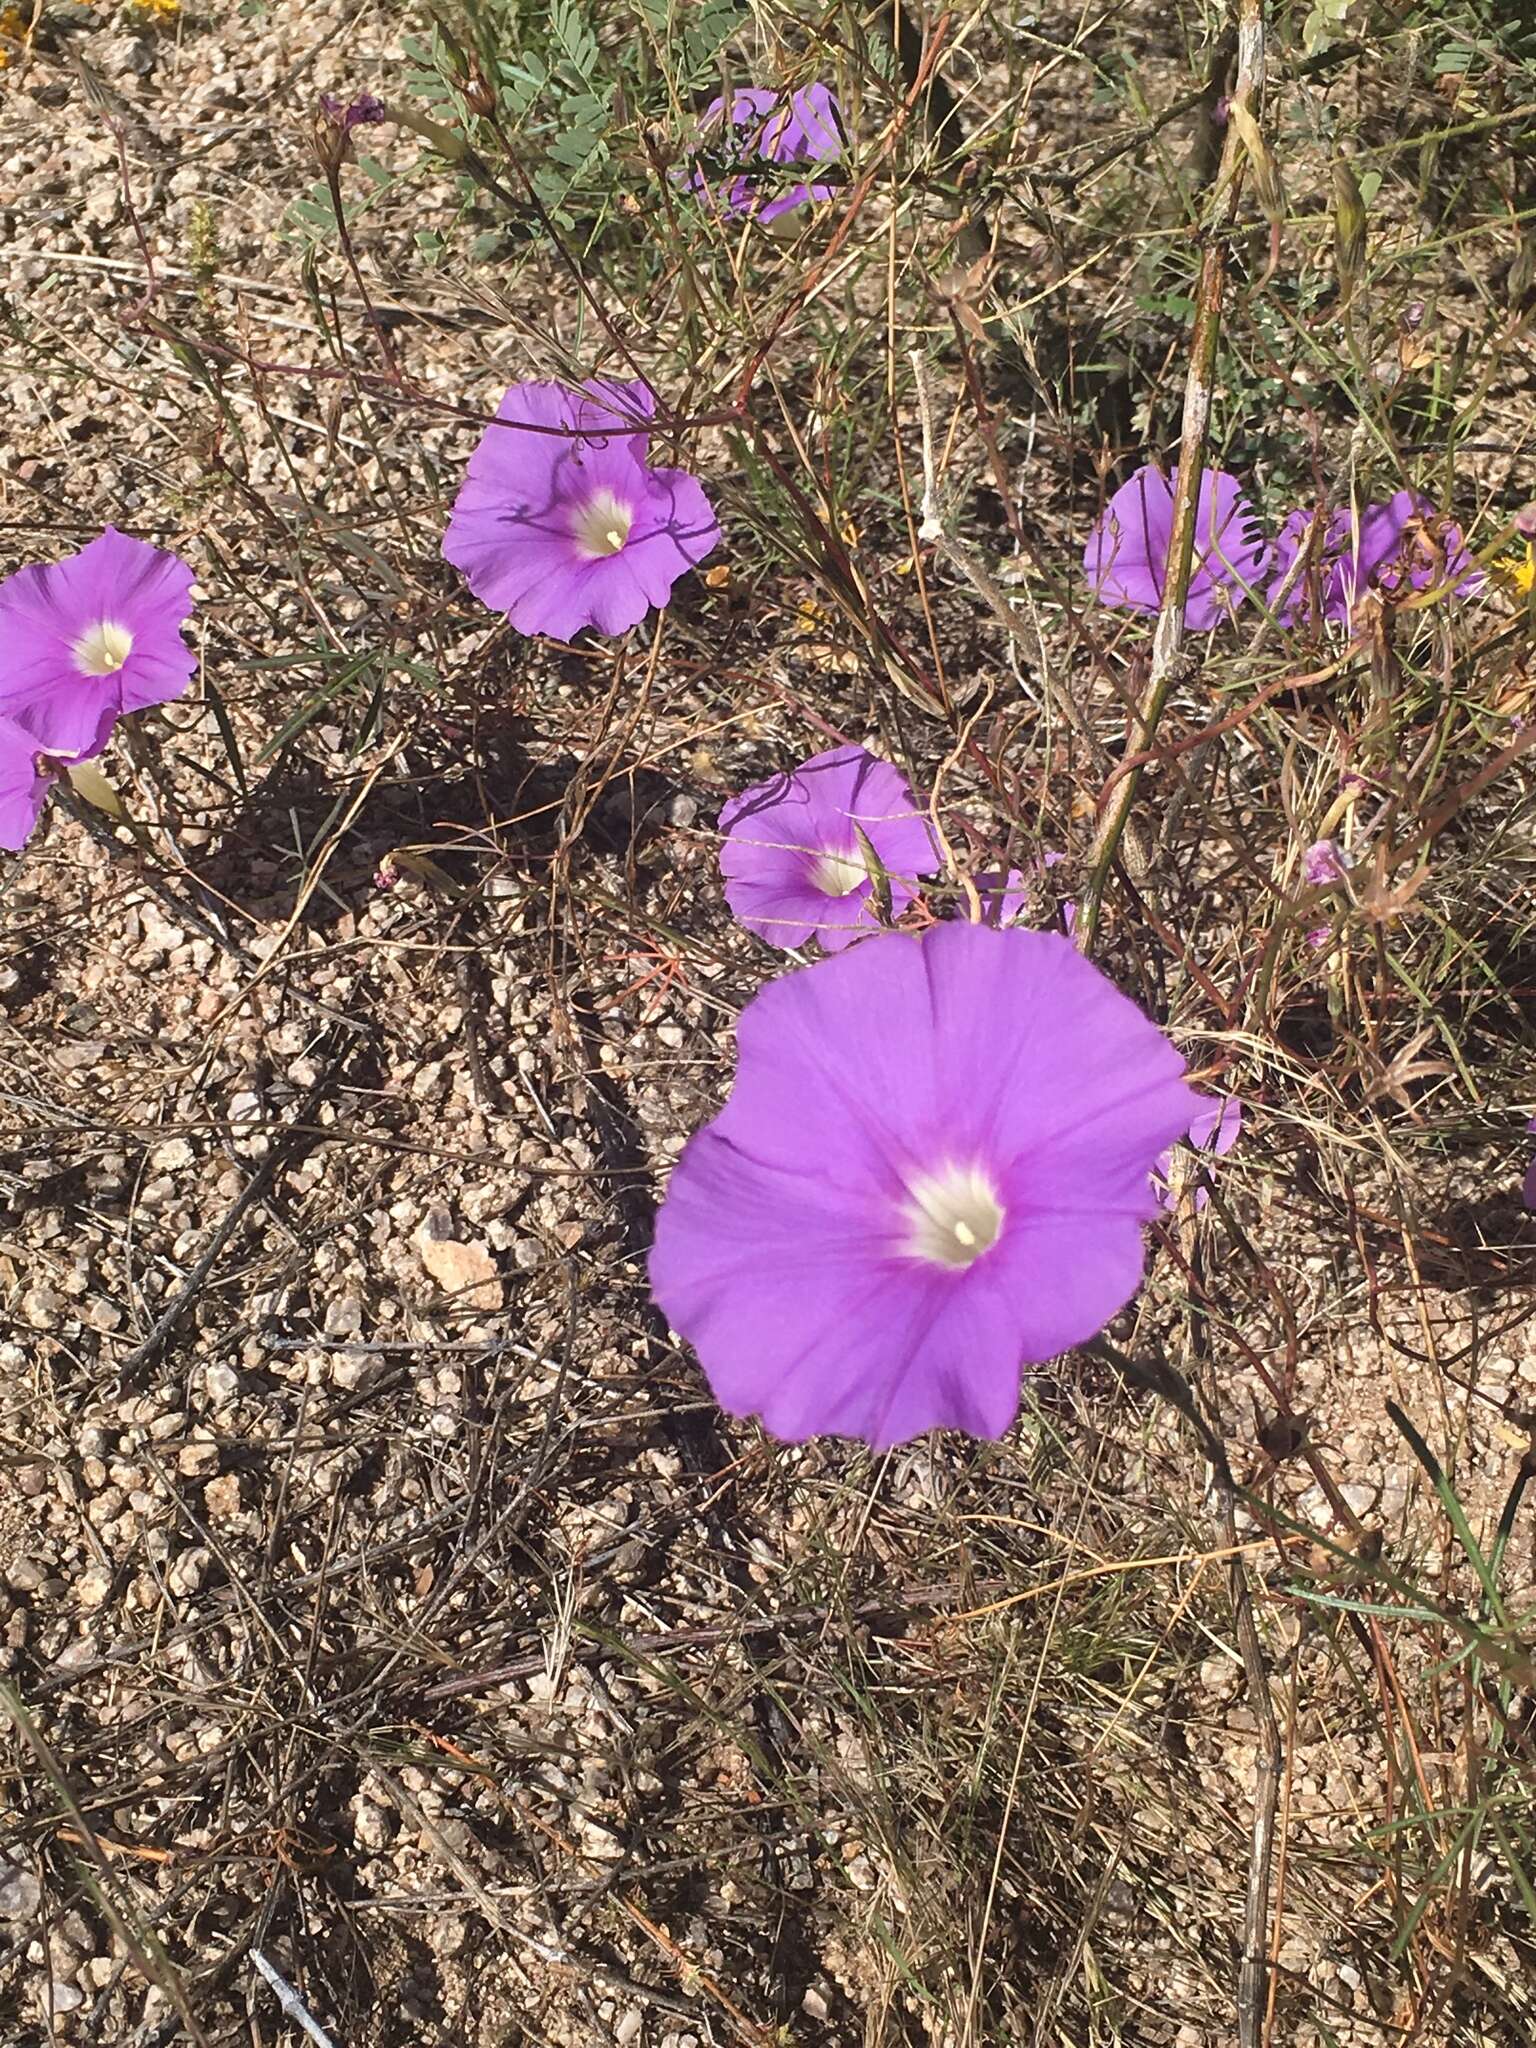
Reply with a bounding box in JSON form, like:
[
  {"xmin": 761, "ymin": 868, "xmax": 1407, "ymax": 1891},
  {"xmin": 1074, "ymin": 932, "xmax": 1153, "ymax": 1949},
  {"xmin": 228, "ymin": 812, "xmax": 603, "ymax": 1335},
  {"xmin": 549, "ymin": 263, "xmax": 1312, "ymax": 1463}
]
[{"xmin": 1083, "ymin": 465, "xmax": 1270, "ymax": 633}]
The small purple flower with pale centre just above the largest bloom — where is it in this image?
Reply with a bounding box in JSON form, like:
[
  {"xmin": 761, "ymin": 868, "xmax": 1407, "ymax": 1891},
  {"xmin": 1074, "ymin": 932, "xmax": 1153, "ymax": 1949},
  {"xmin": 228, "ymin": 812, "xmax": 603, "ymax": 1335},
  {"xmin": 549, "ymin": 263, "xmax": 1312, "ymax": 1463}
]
[{"xmin": 721, "ymin": 748, "xmax": 940, "ymax": 952}]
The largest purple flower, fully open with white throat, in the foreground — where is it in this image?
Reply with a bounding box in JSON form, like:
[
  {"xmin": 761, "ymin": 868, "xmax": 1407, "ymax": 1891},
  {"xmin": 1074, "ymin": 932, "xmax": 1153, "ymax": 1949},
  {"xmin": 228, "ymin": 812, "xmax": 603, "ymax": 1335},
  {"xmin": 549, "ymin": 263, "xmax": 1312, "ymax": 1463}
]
[{"xmin": 651, "ymin": 922, "xmax": 1198, "ymax": 1450}]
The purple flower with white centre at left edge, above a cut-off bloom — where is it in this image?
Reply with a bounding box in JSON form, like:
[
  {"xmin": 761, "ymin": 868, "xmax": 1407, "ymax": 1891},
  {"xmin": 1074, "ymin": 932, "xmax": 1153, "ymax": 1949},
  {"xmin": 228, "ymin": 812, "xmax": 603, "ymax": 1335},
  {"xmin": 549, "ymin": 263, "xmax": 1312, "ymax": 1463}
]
[{"xmin": 0, "ymin": 526, "xmax": 197, "ymax": 760}]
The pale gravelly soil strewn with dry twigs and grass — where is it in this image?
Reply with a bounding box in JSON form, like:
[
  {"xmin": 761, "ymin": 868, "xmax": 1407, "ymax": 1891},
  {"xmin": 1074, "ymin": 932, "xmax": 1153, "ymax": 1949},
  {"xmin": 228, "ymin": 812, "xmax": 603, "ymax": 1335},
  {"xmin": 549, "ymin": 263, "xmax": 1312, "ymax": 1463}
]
[{"xmin": 0, "ymin": 4, "xmax": 1536, "ymax": 2048}]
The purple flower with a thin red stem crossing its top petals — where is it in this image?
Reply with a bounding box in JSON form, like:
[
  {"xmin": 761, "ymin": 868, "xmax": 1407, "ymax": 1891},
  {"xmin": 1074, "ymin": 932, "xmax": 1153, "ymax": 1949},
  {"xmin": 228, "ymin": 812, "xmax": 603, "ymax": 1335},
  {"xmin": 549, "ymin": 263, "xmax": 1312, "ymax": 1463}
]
[{"xmin": 442, "ymin": 379, "xmax": 721, "ymax": 639}]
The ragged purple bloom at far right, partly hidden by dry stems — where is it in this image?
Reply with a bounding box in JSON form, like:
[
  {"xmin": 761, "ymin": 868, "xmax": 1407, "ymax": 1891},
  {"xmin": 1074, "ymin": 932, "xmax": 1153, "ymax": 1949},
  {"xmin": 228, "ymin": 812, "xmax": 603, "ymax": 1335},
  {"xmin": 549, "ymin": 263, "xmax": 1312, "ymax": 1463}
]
[{"xmin": 1270, "ymin": 492, "xmax": 1483, "ymax": 625}]
